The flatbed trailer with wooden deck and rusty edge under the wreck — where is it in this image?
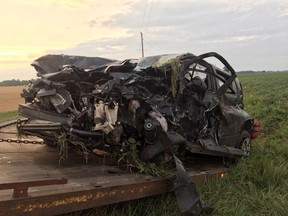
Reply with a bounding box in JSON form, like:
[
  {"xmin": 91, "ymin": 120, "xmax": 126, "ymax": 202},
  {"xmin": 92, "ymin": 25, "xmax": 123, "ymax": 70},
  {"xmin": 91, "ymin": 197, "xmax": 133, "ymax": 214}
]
[{"xmin": 0, "ymin": 125, "xmax": 227, "ymax": 216}]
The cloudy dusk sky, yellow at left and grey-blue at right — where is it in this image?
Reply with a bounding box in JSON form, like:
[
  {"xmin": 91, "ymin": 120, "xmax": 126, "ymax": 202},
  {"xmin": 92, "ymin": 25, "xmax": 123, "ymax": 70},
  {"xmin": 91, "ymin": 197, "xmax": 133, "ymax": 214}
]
[{"xmin": 0, "ymin": 0, "xmax": 288, "ymax": 81}]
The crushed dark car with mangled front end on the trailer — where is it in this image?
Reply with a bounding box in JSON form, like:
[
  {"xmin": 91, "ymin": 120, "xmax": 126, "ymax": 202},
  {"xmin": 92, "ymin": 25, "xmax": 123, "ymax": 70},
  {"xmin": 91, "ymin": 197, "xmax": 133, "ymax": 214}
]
[{"xmin": 18, "ymin": 52, "xmax": 257, "ymax": 162}]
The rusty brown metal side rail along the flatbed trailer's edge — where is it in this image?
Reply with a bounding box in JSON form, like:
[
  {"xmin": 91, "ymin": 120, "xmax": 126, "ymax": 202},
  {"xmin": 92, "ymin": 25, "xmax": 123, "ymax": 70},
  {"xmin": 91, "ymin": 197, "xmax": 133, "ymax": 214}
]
[{"xmin": 0, "ymin": 169, "xmax": 226, "ymax": 216}]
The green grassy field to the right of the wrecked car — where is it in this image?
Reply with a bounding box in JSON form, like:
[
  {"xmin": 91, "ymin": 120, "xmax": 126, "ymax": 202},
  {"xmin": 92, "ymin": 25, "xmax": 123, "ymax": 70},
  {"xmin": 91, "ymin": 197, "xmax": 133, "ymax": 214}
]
[{"xmin": 201, "ymin": 73, "xmax": 288, "ymax": 215}]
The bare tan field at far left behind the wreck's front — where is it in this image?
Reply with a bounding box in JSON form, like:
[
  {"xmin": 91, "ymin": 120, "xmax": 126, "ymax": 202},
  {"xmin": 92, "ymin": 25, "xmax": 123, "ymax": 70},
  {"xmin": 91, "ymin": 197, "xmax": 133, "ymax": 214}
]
[{"xmin": 0, "ymin": 86, "xmax": 25, "ymax": 112}]
